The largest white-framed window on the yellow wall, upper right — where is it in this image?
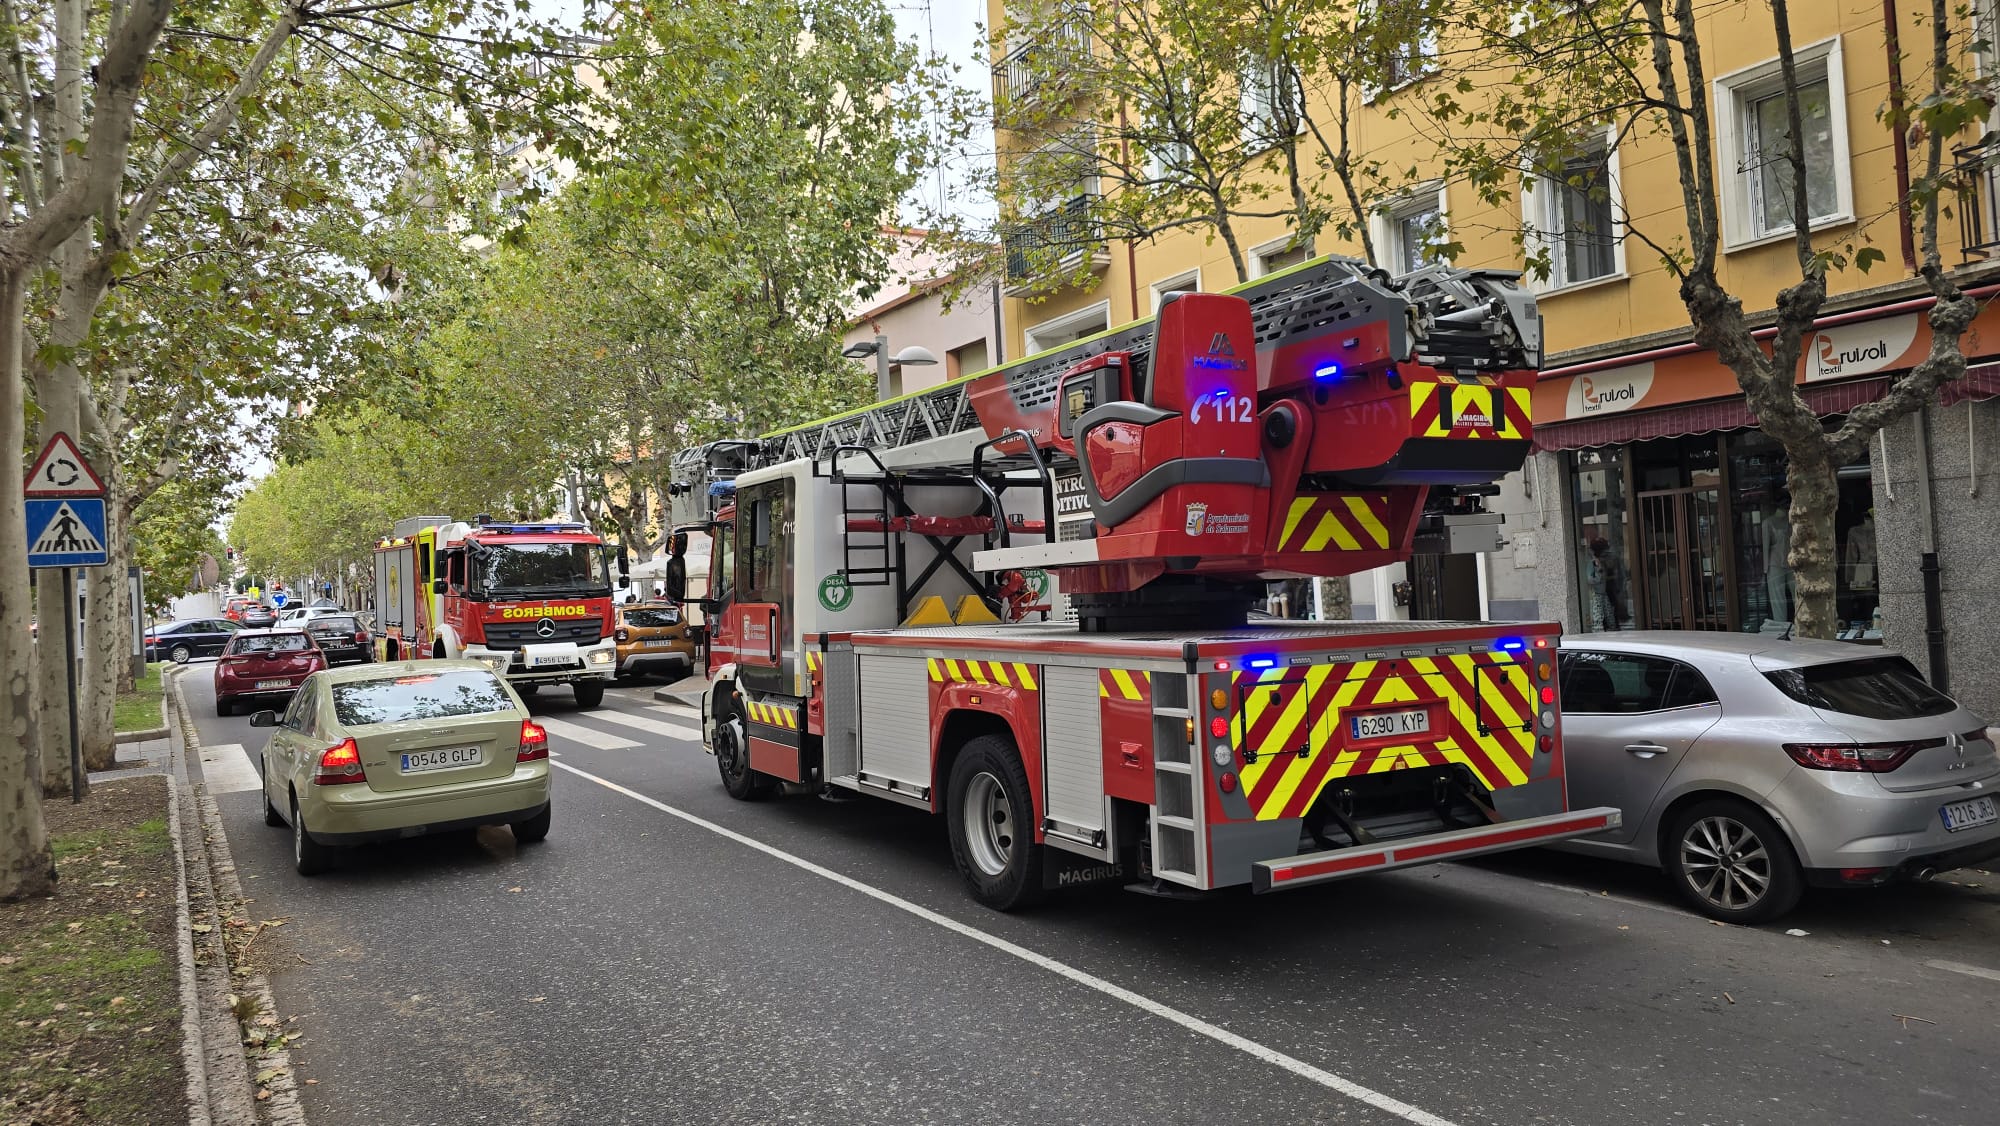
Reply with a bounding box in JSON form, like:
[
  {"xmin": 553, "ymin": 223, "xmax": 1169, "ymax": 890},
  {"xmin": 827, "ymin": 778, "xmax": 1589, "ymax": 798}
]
[{"xmin": 1716, "ymin": 38, "xmax": 1854, "ymax": 246}]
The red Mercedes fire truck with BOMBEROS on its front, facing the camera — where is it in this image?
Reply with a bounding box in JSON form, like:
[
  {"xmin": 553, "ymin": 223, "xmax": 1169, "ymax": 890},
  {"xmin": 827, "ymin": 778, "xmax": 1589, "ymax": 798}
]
[{"xmin": 374, "ymin": 514, "xmax": 618, "ymax": 708}]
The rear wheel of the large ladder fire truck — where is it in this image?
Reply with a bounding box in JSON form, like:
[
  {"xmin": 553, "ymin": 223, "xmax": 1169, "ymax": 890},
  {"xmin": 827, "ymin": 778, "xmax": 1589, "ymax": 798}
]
[{"xmin": 944, "ymin": 734, "xmax": 1042, "ymax": 910}]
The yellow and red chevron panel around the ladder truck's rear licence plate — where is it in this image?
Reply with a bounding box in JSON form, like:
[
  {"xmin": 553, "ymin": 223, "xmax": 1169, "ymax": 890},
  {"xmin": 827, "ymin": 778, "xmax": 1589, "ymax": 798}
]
[{"xmin": 1230, "ymin": 652, "xmax": 1534, "ymax": 820}]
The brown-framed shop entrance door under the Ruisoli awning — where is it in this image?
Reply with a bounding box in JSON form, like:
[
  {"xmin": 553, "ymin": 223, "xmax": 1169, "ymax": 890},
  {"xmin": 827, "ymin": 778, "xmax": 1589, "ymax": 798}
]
[{"xmin": 1638, "ymin": 488, "xmax": 1730, "ymax": 630}]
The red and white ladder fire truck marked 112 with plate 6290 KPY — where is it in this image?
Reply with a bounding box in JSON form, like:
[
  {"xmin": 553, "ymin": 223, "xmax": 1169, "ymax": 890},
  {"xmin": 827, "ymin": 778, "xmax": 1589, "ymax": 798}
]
[{"xmin": 668, "ymin": 256, "xmax": 1620, "ymax": 910}]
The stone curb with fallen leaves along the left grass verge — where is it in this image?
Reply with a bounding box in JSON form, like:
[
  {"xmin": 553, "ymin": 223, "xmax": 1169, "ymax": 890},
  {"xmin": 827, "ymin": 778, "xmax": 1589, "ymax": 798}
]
[{"xmin": 166, "ymin": 676, "xmax": 306, "ymax": 1126}]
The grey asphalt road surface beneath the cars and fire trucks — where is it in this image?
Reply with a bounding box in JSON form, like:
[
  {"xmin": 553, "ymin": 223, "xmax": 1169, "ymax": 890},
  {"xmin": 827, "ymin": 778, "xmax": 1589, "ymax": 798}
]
[{"xmin": 182, "ymin": 664, "xmax": 2000, "ymax": 1126}]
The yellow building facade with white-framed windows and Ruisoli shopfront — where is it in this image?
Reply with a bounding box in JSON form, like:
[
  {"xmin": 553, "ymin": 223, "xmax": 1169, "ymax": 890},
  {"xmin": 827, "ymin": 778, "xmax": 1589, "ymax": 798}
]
[{"xmin": 988, "ymin": 0, "xmax": 2000, "ymax": 714}]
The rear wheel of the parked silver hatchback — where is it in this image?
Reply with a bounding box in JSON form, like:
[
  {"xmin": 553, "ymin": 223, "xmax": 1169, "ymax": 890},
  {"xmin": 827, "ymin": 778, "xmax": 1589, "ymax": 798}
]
[{"xmin": 1660, "ymin": 798, "xmax": 1806, "ymax": 926}]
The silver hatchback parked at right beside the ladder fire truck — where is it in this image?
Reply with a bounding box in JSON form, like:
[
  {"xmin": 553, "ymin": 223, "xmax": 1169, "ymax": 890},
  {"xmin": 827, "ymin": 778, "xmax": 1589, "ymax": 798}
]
[{"xmin": 1560, "ymin": 630, "xmax": 2000, "ymax": 922}]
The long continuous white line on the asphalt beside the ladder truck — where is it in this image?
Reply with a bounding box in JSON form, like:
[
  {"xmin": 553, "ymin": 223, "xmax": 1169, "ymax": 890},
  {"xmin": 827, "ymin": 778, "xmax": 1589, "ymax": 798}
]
[{"xmin": 556, "ymin": 762, "xmax": 1452, "ymax": 1126}]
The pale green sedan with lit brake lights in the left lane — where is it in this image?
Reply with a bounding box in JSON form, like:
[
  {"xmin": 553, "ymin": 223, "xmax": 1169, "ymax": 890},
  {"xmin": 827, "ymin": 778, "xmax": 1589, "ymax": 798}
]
[{"xmin": 250, "ymin": 660, "xmax": 564, "ymax": 876}]
